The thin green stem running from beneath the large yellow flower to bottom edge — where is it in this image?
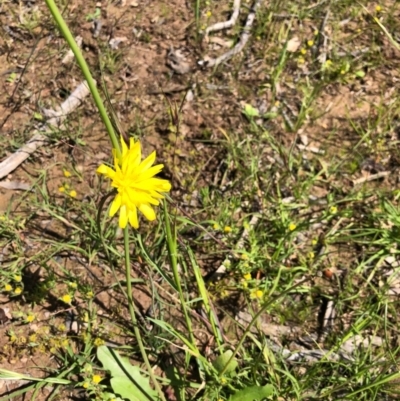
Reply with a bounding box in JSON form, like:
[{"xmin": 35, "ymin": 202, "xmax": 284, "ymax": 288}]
[{"xmin": 124, "ymin": 226, "xmax": 166, "ymax": 401}]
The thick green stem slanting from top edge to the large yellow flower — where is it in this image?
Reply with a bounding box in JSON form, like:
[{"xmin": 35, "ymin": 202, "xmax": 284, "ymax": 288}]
[{"xmin": 45, "ymin": 0, "xmax": 121, "ymax": 157}]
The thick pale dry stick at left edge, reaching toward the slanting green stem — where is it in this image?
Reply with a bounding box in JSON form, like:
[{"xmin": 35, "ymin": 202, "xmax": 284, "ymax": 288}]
[{"xmin": 0, "ymin": 81, "xmax": 89, "ymax": 179}]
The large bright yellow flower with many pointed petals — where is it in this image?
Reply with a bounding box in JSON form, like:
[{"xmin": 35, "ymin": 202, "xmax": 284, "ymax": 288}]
[{"xmin": 97, "ymin": 138, "xmax": 171, "ymax": 228}]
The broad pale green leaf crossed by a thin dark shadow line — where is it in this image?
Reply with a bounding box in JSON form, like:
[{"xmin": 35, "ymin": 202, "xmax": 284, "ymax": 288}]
[{"xmin": 97, "ymin": 345, "xmax": 159, "ymax": 401}]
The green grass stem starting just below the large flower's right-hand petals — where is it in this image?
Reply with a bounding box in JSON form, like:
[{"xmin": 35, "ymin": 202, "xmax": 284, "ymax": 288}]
[{"xmin": 163, "ymin": 199, "xmax": 197, "ymax": 349}]
